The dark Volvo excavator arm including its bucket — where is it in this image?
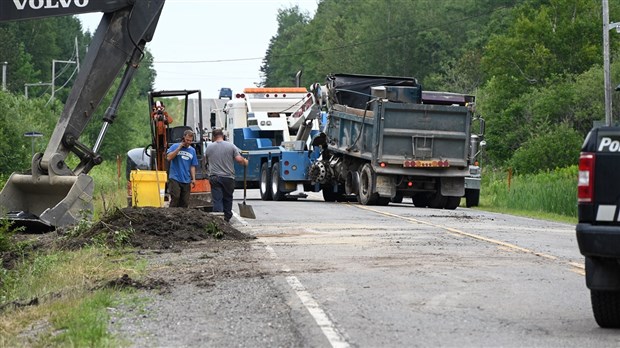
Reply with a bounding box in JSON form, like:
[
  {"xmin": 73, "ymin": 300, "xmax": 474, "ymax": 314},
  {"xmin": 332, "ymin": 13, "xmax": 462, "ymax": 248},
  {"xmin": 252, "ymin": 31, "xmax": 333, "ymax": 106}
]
[{"xmin": 0, "ymin": 0, "xmax": 165, "ymax": 229}]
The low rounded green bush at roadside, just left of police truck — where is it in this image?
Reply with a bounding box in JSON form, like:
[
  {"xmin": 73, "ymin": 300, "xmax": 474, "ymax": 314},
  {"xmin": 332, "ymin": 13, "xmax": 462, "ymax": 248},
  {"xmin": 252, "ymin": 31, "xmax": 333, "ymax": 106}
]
[{"xmin": 510, "ymin": 125, "xmax": 583, "ymax": 174}]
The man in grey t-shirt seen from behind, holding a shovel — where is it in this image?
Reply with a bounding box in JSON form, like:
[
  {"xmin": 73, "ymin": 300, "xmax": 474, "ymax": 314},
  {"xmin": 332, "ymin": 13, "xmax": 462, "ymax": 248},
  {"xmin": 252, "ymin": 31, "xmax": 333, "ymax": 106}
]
[{"xmin": 205, "ymin": 129, "xmax": 248, "ymax": 222}]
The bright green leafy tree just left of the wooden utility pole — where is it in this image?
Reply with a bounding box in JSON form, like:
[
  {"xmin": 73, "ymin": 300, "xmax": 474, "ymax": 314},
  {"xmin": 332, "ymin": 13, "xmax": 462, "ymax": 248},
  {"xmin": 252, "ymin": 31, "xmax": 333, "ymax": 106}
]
[{"xmin": 481, "ymin": 0, "xmax": 602, "ymax": 164}]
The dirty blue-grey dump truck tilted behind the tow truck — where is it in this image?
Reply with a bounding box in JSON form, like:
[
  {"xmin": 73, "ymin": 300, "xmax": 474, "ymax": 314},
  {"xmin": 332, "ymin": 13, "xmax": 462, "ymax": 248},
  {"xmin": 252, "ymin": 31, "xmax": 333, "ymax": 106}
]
[{"xmin": 309, "ymin": 74, "xmax": 484, "ymax": 209}]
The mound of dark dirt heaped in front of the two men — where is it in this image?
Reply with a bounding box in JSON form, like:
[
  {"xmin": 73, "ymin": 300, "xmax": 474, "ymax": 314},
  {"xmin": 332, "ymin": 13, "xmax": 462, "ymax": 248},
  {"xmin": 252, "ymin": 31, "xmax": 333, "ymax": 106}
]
[{"xmin": 59, "ymin": 207, "xmax": 255, "ymax": 249}]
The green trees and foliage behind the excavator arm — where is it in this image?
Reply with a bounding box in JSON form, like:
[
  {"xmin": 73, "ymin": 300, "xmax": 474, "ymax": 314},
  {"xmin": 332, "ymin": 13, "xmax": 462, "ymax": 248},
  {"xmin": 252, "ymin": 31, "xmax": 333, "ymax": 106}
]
[{"xmin": 0, "ymin": 16, "xmax": 155, "ymax": 177}]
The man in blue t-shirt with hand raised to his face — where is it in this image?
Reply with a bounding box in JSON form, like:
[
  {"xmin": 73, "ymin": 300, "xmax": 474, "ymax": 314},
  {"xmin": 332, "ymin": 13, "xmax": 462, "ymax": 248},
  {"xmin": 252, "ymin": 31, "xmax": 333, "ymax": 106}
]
[{"xmin": 166, "ymin": 129, "xmax": 198, "ymax": 208}]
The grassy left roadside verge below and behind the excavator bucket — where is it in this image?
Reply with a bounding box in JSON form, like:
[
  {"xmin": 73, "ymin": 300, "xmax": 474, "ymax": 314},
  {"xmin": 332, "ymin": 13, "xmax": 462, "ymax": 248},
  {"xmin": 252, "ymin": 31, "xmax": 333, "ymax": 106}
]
[{"xmin": 0, "ymin": 163, "xmax": 146, "ymax": 347}]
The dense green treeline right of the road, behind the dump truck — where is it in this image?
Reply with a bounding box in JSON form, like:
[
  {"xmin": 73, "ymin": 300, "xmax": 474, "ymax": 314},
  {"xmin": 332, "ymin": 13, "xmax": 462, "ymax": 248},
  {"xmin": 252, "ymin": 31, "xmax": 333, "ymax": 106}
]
[{"xmin": 261, "ymin": 0, "xmax": 620, "ymax": 174}]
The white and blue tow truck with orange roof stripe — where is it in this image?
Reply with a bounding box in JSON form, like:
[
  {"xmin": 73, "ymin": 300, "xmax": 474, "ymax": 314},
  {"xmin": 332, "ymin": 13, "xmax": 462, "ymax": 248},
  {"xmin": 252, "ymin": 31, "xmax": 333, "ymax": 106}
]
[{"xmin": 215, "ymin": 87, "xmax": 320, "ymax": 201}]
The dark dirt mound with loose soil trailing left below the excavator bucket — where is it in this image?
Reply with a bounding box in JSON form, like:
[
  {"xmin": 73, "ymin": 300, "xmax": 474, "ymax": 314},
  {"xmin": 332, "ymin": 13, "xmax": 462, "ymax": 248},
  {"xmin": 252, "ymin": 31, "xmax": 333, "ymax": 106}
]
[{"xmin": 0, "ymin": 207, "xmax": 255, "ymax": 269}]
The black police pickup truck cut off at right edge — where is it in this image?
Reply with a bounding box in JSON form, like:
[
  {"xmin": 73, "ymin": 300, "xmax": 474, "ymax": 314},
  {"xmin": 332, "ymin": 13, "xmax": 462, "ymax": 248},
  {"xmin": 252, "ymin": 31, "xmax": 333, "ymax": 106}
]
[{"xmin": 577, "ymin": 127, "xmax": 620, "ymax": 328}]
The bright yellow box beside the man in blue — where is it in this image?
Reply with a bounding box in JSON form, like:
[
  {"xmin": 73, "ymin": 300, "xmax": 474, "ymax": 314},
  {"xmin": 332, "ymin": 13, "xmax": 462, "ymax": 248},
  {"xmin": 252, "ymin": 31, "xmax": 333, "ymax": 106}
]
[{"xmin": 130, "ymin": 170, "xmax": 168, "ymax": 207}]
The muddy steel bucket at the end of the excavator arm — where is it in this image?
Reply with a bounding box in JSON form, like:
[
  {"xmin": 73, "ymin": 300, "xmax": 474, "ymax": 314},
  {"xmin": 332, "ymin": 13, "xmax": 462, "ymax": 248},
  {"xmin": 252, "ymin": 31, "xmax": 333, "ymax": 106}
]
[{"xmin": 0, "ymin": 173, "xmax": 94, "ymax": 231}]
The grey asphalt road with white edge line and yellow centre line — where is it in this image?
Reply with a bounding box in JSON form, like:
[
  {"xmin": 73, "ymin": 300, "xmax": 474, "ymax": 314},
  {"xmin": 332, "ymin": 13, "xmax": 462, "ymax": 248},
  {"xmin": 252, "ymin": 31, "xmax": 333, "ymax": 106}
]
[{"xmin": 117, "ymin": 190, "xmax": 620, "ymax": 347}]
